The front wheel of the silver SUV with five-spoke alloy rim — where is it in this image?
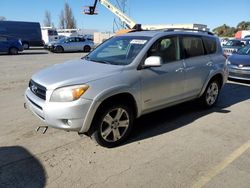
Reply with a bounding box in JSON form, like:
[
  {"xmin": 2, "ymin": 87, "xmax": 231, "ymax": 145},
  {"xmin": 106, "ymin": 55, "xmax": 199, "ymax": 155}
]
[{"xmin": 91, "ymin": 104, "xmax": 134, "ymax": 148}]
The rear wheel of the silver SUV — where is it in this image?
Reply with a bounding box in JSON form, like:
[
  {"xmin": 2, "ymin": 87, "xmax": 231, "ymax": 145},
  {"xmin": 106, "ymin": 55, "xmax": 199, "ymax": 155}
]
[{"xmin": 200, "ymin": 80, "xmax": 221, "ymax": 108}]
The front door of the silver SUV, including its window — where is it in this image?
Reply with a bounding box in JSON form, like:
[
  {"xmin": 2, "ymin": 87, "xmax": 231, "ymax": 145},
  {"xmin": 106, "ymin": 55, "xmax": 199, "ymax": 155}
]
[{"xmin": 141, "ymin": 36, "xmax": 185, "ymax": 111}]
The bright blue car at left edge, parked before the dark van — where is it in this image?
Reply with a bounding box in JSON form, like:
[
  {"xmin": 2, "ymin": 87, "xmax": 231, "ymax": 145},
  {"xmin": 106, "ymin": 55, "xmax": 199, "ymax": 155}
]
[{"xmin": 0, "ymin": 35, "xmax": 23, "ymax": 55}]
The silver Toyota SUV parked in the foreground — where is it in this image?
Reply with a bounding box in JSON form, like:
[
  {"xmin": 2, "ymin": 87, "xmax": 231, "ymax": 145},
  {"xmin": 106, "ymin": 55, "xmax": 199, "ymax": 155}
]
[{"xmin": 25, "ymin": 29, "xmax": 228, "ymax": 147}]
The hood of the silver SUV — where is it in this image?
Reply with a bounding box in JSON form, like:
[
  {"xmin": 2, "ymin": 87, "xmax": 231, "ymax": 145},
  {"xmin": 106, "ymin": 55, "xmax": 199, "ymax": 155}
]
[{"xmin": 32, "ymin": 59, "xmax": 123, "ymax": 89}]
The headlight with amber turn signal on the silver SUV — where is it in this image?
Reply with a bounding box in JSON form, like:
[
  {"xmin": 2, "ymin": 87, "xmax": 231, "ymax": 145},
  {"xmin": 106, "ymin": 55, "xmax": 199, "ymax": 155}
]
[{"xmin": 50, "ymin": 85, "xmax": 89, "ymax": 102}]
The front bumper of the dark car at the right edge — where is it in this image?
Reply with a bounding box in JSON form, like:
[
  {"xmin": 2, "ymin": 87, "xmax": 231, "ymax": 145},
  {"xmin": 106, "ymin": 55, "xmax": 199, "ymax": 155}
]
[{"xmin": 228, "ymin": 65, "xmax": 250, "ymax": 80}]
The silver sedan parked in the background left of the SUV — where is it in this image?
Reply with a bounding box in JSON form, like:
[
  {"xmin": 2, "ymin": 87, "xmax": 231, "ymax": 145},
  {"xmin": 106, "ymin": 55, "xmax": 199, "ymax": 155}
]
[{"xmin": 48, "ymin": 37, "xmax": 94, "ymax": 53}]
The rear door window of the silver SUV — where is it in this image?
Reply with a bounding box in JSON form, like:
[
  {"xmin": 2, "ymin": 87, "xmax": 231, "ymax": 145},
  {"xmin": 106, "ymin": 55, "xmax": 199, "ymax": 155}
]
[{"xmin": 182, "ymin": 36, "xmax": 204, "ymax": 58}]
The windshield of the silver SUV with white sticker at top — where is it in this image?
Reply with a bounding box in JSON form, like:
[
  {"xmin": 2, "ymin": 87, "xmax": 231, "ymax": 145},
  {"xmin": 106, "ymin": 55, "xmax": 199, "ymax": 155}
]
[{"xmin": 85, "ymin": 36, "xmax": 150, "ymax": 65}]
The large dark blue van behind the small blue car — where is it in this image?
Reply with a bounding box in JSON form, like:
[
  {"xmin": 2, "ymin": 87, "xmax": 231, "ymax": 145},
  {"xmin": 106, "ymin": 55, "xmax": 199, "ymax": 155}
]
[{"xmin": 0, "ymin": 21, "xmax": 43, "ymax": 49}]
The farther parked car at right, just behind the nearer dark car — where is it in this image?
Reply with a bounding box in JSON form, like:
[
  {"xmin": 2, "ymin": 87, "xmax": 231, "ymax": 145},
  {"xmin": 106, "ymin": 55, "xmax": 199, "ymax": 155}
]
[{"xmin": 222, "ymin": 38, "xmax": 250, "ymax": 56}]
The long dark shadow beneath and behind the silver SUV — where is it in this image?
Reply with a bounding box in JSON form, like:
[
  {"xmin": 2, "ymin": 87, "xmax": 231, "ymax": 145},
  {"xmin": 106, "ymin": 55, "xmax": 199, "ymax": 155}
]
[{"xmin": 125, "ymin": 82, "xmax": 250, "ymax": 144}]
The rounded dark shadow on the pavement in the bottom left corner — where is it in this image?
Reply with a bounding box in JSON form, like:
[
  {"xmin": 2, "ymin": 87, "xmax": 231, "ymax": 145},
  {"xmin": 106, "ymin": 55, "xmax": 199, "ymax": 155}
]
[{"xmin": 0, "ymin": 146, "xmax": 46, "ymax": 188}]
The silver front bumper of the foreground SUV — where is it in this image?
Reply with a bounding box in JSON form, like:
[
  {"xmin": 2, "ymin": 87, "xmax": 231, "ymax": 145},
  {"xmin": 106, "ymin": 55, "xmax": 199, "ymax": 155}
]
[{"xmin": 25, "ymin": 88, "xmax": 92, "ymax": 132}]
